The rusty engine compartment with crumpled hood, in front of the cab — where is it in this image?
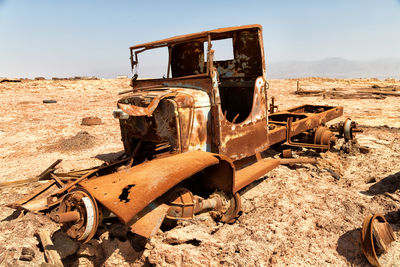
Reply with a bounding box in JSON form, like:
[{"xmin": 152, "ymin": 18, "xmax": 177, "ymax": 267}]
[{"xmin": 118, "ymin": 87, "xmax": 211, "ymax": 154}]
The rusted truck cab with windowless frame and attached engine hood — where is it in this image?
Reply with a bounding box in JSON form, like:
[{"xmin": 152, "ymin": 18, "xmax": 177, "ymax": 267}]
[{"xmin": 114, "ymin": 25, "xmax": 269, "ymax": 160}]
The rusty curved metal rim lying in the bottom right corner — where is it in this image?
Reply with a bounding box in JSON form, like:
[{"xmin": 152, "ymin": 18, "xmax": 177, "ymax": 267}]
[{"xmin": 361, "ymin": 214, "xmax": 396, "ymax": 267}]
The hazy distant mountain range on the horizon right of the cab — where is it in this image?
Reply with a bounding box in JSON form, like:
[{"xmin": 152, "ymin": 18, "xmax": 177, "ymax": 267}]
[{"xmin": 267, "ymin": 58, "xmax": 400, "ymax": 79}]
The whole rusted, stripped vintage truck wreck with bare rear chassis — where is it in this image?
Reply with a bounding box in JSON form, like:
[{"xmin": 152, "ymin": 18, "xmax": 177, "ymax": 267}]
[{"xmin": 9, "ymin": 25, "xmax": 354, "ymax": 245}]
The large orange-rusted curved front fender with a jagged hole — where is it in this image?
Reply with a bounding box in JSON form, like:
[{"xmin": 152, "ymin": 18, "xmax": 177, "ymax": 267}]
[{"xmin": 80, "ymin": 151, "xmax": 234, "ymax": 223}]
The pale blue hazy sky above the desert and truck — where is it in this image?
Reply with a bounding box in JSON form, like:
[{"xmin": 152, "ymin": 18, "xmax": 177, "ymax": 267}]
[{"xmin": 0, "ymin": 0, "xmax": 400, "ymax": 77}]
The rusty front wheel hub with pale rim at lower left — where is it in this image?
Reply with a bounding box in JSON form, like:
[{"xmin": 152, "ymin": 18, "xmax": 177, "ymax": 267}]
[{"xmin": 56, "ymin": 188, "xmax": 100, "ymax": 243}]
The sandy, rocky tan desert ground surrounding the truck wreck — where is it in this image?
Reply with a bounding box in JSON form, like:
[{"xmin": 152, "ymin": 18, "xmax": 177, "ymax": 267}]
[{"xmin": 0, "ymin": 78, "xmax": 400, "ymax": 266}]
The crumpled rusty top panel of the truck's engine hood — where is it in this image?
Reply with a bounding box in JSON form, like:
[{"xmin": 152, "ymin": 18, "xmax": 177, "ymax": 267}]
[{"xmin": 118, "ymin": 88, "xmax": 209, "ymax": 116}]
